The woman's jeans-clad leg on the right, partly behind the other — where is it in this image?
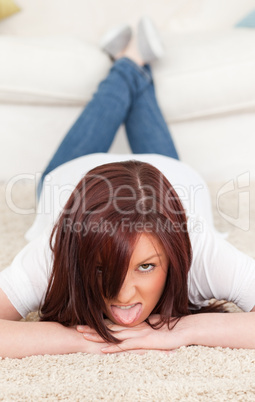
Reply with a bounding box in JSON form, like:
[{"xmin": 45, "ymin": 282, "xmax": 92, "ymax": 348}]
[{"xmin": 125, "ymin": 64, "xmax": 179, "ymax": 159}]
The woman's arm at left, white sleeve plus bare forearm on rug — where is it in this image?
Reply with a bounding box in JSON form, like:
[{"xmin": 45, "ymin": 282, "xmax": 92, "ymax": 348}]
[{"xmin": 0, "ymin": 234, "xmax": 107, "ymax": 358}]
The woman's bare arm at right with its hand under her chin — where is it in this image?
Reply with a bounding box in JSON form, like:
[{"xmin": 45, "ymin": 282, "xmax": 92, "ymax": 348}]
[{"xmin": 77, "ymin": 307, "xmax": 255, "ymax": 353}]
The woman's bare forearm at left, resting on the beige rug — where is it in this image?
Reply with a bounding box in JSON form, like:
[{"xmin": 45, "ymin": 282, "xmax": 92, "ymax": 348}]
[{"xmin": 0, "ymin": 320, "xmax": 88, "ymax": 358}]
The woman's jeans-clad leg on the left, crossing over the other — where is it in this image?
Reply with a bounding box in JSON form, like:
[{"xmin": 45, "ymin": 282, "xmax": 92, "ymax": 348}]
[{"xmin": 38, "ymin": 57, "xmax": 150, "ymax": 194}]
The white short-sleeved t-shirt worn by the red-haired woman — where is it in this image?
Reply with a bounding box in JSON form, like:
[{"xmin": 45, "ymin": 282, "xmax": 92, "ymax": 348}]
[{"xmin": 0, "ymin": 154, "xmax": 255, "ymax": 317}]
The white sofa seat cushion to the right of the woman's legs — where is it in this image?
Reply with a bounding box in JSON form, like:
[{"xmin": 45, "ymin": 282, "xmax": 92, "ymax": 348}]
[{"xmin": 154, "ymin": 29, "xmax": 255, "ymax": 122}]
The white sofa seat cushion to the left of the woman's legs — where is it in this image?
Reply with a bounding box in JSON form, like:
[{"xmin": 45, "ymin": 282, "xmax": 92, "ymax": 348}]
[{"xmin": 0, "ymin": 36, "xmax": 111, "ymax": 105}]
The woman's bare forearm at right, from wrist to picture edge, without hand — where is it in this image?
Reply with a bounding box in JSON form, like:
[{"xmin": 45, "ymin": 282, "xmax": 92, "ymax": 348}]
[{"xmin": 184, "ymin": 312, "xmax": 255, "ymax": 349}]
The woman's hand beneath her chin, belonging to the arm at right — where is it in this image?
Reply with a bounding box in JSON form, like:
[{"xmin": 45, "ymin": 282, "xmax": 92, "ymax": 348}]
[{"xmin": 77, "ymin": 315, "xmax": 190, "ymax": 353}]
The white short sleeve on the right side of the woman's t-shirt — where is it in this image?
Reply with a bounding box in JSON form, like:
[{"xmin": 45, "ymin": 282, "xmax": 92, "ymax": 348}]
[{"xmin": 188, "ymin": 217, "xmax": 255, "ymax": 312}]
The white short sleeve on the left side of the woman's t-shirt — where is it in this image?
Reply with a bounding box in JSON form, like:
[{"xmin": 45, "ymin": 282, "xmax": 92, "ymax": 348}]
[{"xmin": 0, "ymin": 231, "xmax": 52, "ymax": 317}]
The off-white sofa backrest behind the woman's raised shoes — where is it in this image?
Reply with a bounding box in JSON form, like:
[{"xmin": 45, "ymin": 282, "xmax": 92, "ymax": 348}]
[{"xmin": 0, "ymin": 0, "xmax": 255, "ymax": 38}]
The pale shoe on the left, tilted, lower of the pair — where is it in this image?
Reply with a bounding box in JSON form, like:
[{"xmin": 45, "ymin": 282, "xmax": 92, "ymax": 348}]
[{"xmin": 99, "ymin": 24, "xmax": 132, "ymax": 58}]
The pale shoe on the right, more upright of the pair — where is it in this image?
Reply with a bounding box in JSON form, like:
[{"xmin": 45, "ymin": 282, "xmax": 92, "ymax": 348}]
[{"xmin": 137, "ymin": 17, "xmax": 165, "ymax": 63}]
